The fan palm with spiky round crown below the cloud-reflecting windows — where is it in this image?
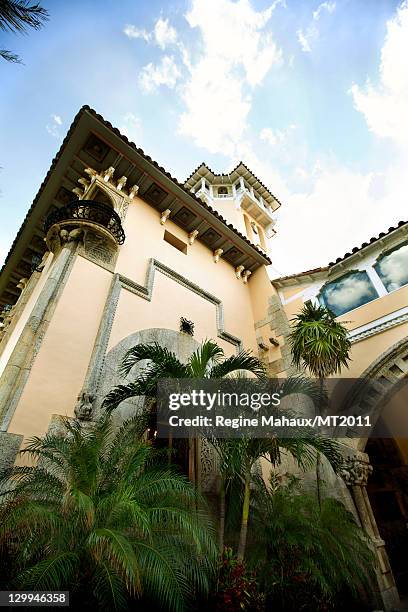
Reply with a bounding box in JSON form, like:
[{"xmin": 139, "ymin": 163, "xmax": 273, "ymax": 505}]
[{"xmin": 289, "ymin": 301, "xmax": 351, "ymax": 506}]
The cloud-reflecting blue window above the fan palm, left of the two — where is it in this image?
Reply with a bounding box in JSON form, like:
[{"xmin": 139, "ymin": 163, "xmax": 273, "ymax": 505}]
[{"xmin": 319, "ymin": 271, "xmax": 378, "ymax": 317}]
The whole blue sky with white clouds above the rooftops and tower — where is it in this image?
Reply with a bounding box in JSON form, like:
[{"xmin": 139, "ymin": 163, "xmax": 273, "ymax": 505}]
[{"xmin": 0, "ymin": 0, "xmax": 408, "ymax": 275}]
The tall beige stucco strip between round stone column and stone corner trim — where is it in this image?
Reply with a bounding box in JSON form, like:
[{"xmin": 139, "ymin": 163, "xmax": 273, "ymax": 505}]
[{"xmin": 8, "ymin": 256, "xmax": 111, "ymax": 437}]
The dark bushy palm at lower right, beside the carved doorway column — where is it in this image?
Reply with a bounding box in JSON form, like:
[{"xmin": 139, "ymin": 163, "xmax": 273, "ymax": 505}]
[{"xmin": 250, "ymin": 479, "xmax": 375, "ymax": 610}]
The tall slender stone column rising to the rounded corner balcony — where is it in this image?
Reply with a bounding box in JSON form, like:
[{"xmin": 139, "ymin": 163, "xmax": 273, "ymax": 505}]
[{"xmin": 0, "ymin": 243, "xmax": 76, "ymax": 431}]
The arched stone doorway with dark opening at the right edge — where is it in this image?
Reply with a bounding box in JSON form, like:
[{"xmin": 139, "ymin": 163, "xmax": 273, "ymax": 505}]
[{"xmin": 342, "ymin": 338, "xmax": 408, "ymax": 609}]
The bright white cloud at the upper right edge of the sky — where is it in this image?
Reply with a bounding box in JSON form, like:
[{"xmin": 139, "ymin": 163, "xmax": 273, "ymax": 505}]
[{"xmin": 351, "ymin": 1, "xmax": 408, "ymax": 149}]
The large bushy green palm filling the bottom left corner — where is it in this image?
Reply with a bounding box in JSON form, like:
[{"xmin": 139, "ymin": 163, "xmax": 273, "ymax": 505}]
[{"xmin": 0, "ymin": 417, "xmax": 216, "ymax": 610}]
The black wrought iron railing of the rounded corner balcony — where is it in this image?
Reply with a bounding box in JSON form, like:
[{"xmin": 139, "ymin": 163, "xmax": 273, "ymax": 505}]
[{"xmin": 44, "ymin": 200, "xmax": 125, "ymax": 244}]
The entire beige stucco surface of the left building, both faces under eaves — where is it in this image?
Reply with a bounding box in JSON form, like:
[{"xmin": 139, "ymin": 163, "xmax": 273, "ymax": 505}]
[{"xmin": 5, "ymin": 199, "xmax": 272, "ymax": 437}]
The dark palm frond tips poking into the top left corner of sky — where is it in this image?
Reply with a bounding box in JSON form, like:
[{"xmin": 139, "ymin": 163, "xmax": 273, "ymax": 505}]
[{"xmin": 0, "ymin": 0, "xmax": 48, "ymax": 64}]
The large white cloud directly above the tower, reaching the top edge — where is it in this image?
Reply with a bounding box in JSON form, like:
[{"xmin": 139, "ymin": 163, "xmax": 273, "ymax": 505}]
[{"xmin": 180, "ymin": 0, "xmax": 281, "ymax": 155}]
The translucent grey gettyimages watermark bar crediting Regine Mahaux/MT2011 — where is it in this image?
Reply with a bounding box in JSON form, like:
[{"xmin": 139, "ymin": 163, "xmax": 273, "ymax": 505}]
[{"xmin": 157, "ymin": 376, "xmax": 408, "ymax": 438}]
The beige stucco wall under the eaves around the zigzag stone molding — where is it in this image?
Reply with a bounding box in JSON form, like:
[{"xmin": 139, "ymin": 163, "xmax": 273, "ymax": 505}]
[{"xmin": 109, "ymin": 199, "xmax": 257, "ymax": 352}]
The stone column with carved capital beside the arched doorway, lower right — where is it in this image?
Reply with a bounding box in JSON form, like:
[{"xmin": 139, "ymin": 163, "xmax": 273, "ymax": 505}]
[{"xmin": 342, "ymin": 452, "xmax": 400, "ymax": 610}]
